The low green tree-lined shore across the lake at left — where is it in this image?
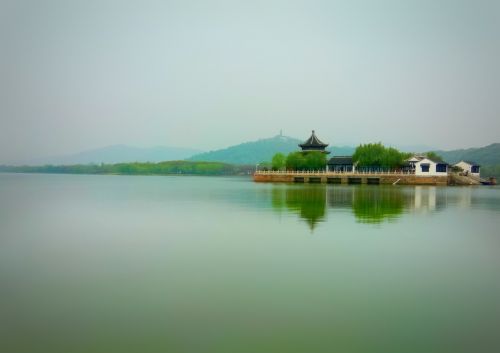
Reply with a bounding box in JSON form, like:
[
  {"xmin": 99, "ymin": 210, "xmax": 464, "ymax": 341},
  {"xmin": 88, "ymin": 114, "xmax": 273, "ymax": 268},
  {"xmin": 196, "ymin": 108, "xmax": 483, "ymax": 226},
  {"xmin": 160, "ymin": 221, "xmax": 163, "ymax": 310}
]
[{"xmin": 0, "ymin": 161, "xmax": 254, "ymax": 175}]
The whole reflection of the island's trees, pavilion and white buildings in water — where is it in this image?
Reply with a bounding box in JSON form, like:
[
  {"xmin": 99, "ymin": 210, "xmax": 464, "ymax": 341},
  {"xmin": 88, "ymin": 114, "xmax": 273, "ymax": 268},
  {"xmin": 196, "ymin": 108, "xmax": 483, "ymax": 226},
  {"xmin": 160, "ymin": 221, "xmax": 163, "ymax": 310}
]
[{"xmin": 271, "ymin": 185, "xmax": 454, "ymax": 230}]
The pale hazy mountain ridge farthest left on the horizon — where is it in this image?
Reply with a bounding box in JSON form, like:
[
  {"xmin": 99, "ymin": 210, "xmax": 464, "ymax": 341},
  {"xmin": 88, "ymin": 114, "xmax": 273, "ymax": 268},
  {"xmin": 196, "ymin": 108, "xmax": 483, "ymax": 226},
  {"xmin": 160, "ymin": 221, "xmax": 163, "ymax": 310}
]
[{"xmin": 15, "ymin": 145, "xmax": 201, "ymax": 165}]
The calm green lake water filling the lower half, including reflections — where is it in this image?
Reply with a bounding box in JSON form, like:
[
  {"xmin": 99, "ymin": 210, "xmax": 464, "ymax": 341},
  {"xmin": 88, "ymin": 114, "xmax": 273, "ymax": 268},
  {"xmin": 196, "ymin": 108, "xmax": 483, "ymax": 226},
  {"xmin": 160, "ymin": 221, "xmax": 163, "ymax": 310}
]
[{"xmin": 0, "ymin": 174, "xmax": 500, "ymax": 353}]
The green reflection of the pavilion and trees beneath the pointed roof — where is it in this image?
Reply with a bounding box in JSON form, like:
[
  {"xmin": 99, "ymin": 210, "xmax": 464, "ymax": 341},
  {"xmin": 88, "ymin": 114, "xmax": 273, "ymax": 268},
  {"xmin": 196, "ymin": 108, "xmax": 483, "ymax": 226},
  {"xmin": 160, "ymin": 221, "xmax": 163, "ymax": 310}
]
[{"xmin": 272, "ymin": 185, "xmax": 326, "ymax": 229}]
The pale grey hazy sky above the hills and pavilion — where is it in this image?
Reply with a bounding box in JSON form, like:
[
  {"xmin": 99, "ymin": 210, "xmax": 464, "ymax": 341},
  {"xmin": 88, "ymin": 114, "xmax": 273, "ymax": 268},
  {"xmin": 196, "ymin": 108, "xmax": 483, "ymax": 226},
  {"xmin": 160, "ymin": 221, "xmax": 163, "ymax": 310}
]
[{"xmin": 0, "ymin": 0, "xmax": 500, "ymax": 162}]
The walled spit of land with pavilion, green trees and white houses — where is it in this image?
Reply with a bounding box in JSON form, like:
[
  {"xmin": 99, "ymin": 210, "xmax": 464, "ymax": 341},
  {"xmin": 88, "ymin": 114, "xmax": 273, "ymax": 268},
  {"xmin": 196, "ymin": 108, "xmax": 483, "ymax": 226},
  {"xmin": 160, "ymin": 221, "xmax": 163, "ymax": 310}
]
[{"xmin": 253, "ymin": 130, "xmax": 496, "ymax": 185}]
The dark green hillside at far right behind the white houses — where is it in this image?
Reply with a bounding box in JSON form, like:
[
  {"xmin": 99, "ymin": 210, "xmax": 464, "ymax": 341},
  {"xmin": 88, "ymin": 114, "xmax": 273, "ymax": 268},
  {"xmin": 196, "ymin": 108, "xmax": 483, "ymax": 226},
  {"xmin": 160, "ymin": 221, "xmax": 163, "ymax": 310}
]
[{"xmin": 435, "ymin": 143, "xmax": 500, "ymax": 166}]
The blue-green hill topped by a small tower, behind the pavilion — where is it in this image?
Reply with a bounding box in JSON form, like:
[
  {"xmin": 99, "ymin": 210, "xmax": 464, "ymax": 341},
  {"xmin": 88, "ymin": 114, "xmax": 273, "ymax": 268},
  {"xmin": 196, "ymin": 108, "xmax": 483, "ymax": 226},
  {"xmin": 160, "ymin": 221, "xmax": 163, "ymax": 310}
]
[{"xmin": 189, "ymin": 135, "xmax": 354, "ymax": 164}]
